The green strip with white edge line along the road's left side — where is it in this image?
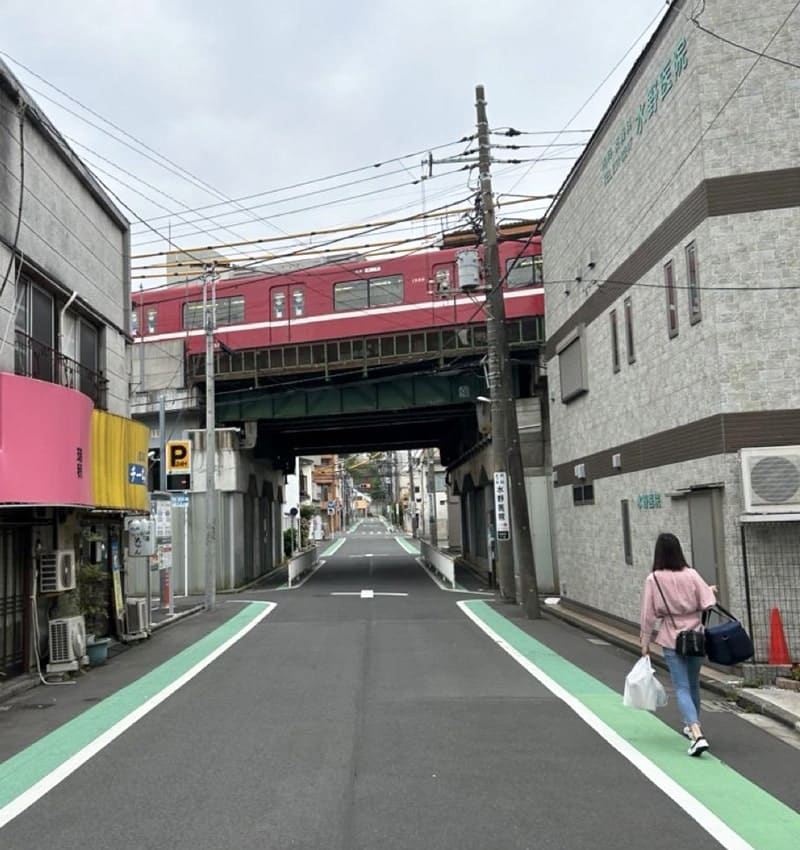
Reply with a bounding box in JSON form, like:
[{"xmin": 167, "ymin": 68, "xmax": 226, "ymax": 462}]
[{"xmin": 0, "ymin": 602, "xmax": 276, "ymax": 829}]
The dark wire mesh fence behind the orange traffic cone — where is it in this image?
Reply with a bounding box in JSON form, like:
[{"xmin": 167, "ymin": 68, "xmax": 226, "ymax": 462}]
[{"xmin": 741, "ymin": 522, "xmax": 800, "ymax": 664}]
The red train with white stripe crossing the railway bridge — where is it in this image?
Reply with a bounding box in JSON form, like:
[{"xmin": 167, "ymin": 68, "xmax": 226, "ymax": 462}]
[{"xmin": 133, "ymin": 236, "xmax": 544, "ymax": 353}]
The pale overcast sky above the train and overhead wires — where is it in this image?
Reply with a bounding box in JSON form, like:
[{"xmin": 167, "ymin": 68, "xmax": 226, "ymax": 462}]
[{"xmin": 0, "ymin": 0, "xmax": 666, "ymax": 283}]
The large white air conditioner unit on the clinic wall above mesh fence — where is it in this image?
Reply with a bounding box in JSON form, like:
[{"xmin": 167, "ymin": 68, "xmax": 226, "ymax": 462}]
[{"xmin": 739, "ymin": 446, "xmax": 800, "ymax": 514}]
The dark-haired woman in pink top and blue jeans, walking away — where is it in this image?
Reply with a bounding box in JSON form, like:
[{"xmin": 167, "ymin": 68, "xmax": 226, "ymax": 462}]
[{"xmin": 640, "ymin": 533, "xmax": 716, "ymax": 756}]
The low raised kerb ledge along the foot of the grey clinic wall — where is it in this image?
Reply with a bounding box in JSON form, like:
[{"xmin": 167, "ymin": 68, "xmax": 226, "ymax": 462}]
[{"xmin": 542, "ymin": 600, "xmax": 800, "ymax": 732}]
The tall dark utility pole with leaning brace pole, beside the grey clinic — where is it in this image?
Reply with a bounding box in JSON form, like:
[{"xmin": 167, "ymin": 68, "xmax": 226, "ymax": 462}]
[{"xmin": 475, "ymin": 86, "xmax": 541, "ymax": 618}]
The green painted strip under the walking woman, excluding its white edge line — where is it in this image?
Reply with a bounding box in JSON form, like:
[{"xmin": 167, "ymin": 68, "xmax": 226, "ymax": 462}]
[{"xmin": 459, "ymin": 601, "xmax": 800, "ymax": 850}]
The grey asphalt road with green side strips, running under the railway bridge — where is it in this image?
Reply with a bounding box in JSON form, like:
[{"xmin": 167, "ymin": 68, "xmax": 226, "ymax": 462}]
[{"xmin": 0, "ymin": 520, "xmax": 800, "ymax": 850}]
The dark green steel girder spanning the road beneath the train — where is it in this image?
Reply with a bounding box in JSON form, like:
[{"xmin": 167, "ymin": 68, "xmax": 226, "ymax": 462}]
[{"xmin": 216, "ymin": 371, "xmax": 486, "ymax": 424}]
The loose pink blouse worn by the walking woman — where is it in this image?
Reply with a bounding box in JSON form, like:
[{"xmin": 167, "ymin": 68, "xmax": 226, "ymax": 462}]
[{"xmin": 639, "ymin": 567, "xmax": 716, "ymax": 649}]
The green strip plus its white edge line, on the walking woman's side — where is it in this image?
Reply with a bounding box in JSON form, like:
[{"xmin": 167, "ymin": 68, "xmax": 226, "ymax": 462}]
[{"xmin": 457, "ymin": 601, "xmax": 800, "ymax": 850}]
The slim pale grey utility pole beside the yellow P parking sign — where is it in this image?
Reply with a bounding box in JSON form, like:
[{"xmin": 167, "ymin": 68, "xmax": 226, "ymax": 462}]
[{"xmin": 203, "ymin": 265, "xmax": 217, "ymax": 611}]
